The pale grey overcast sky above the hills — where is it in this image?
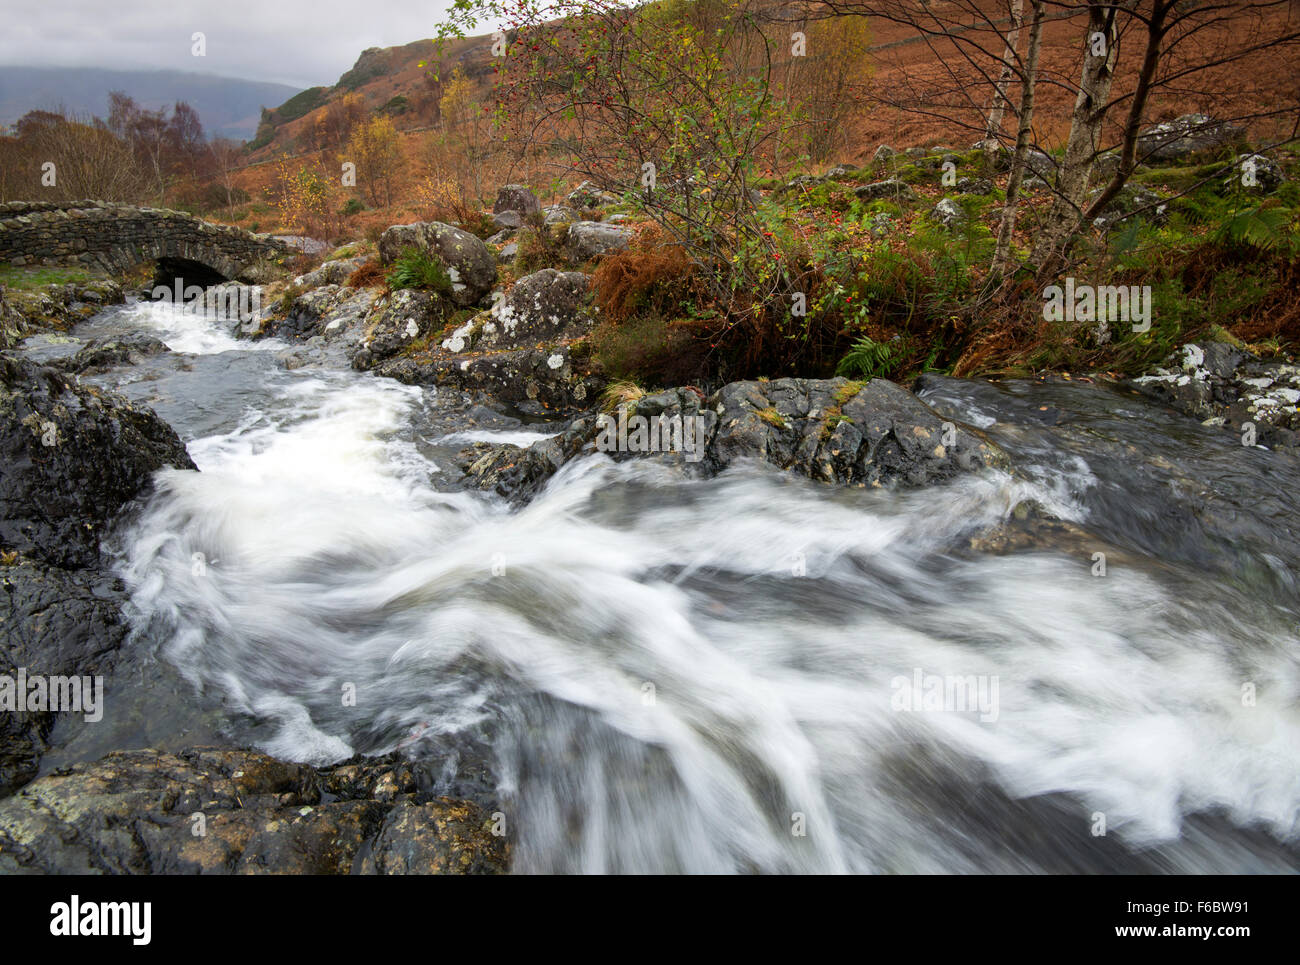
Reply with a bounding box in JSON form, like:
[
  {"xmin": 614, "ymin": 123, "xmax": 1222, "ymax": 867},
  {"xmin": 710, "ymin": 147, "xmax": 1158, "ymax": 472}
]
[{"xmin": 0, "ymin": 0, "xmax": 473, "ymax": 87}]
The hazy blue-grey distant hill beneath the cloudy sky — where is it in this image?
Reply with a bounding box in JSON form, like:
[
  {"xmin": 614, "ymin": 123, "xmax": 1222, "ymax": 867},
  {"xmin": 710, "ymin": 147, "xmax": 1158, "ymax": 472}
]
[{"xmin": 0, "ymin": 66, "xmax": 298, "ymax": 140}]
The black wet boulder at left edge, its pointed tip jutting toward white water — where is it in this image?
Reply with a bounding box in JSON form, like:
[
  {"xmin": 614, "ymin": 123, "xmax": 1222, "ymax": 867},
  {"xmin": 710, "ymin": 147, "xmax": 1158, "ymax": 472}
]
[{"xmin": 0, "ymin": 355, "xmax": 194, "ymax": 567}]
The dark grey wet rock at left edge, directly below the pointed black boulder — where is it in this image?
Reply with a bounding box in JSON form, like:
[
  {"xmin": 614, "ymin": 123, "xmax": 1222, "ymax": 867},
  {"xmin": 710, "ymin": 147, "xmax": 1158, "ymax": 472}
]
[{"xmin": 0, "ymin": 554, "xmax": 130, "ymax": 797}]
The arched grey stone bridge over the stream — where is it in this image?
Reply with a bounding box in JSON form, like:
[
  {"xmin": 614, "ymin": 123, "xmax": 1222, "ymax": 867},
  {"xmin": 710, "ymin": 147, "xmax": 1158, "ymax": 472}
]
[{"xmin": 0, "ymin": 200, "xmax": 291, "ymax": 285}]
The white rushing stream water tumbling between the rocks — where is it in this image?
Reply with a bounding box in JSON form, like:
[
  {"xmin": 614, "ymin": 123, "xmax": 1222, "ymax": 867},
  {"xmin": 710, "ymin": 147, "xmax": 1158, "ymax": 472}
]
[{"xmin": 20, "ymin": 296, "xmax": 1300, "ymax": 873}]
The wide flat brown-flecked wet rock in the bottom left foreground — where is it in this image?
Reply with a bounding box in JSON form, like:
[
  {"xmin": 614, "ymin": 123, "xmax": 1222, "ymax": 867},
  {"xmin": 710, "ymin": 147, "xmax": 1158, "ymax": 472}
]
[{"xmin": 0, "ymin": 748, "xmax": 508, "ymax": 874}]
